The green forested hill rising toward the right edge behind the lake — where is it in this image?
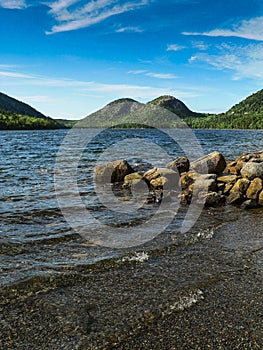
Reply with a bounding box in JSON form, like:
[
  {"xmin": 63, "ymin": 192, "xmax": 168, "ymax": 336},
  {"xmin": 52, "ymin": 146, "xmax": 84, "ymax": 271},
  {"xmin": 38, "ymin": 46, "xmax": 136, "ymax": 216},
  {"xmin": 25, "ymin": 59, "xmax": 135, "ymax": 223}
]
[{"xmin": 187, "ymin": 90, "xmax": 263, "ymax": 129}]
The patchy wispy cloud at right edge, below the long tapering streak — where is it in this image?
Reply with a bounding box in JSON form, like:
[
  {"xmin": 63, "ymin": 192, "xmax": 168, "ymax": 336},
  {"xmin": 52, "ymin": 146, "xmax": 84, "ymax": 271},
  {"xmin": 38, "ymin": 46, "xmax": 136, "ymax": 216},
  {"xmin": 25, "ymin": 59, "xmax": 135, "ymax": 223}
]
[{"xmin": 189, "ymin": 44, "xmax": 263, "ymax": 81}]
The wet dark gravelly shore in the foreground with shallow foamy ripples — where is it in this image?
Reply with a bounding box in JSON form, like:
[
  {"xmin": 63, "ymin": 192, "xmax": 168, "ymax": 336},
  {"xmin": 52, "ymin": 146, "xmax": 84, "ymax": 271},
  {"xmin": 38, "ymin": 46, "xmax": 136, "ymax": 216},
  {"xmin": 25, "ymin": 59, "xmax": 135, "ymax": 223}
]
[{"xmin": 0, "ymin": 209, "xmax": 263, "ymax": 350}]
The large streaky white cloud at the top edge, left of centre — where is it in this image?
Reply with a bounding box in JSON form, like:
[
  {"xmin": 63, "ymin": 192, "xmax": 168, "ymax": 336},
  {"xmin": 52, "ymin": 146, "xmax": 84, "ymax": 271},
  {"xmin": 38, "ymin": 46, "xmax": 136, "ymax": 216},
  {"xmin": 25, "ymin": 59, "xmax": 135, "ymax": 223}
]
[{"xmin": 46, "ymin": 0, "xmax": 149, "ymax": 34}]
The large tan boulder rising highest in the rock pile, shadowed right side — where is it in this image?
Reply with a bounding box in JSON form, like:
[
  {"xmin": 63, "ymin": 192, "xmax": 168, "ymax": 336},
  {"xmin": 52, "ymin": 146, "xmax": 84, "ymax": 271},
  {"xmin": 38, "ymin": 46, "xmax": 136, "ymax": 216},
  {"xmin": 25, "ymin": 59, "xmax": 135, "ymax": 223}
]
[{"xmin": 190, "ymin": 151, "xmax": 226, "ymax": 174}]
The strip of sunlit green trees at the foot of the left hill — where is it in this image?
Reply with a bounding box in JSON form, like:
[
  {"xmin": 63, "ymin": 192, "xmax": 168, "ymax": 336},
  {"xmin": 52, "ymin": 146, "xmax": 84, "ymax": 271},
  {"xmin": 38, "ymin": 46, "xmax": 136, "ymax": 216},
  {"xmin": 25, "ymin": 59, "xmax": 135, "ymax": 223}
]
[{"xmin": 0, "ymin": 111, "xmax": 63, "ymax": 130}]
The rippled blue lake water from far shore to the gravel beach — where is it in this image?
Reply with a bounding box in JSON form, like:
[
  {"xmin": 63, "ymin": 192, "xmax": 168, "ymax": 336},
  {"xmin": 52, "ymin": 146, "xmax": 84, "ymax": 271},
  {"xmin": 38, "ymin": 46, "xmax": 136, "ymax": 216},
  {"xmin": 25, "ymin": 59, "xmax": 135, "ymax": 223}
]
[{"xmin": 0, "ymin": 129, "xmax": 263, "ymax": 349}]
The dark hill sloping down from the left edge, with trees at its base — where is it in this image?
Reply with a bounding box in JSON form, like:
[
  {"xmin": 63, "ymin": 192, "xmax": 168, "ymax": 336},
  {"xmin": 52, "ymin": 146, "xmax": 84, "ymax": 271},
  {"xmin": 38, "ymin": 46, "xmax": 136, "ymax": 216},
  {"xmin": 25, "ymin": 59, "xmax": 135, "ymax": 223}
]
[{"xmin": 0, "ymin": 92, "xmax": 64, "ymax": 130}]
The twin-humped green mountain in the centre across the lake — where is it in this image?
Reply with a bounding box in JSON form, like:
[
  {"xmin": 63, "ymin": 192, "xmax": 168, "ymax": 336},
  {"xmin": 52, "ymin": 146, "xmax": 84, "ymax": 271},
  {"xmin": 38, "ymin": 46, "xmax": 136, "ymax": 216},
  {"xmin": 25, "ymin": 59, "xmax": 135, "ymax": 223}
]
[{"xmin": 75, "ymin": 96, "xmax": 204, "ymax": 128}]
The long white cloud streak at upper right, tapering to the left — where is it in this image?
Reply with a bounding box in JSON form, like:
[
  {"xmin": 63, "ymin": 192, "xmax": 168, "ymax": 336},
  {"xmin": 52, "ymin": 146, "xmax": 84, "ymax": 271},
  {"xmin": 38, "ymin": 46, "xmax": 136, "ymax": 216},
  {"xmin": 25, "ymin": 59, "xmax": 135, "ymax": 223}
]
[{"xmin": 185, "ymin": 16, "xmax": 263, "ymax": 41}]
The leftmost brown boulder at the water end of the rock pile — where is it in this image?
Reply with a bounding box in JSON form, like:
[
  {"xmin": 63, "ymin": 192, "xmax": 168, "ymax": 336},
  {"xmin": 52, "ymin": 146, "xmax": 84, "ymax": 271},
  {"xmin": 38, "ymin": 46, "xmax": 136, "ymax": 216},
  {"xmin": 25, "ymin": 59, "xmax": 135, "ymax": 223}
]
[{"xmin": 94, "ymin": 160, "xmax": 134, "ymax": 183}]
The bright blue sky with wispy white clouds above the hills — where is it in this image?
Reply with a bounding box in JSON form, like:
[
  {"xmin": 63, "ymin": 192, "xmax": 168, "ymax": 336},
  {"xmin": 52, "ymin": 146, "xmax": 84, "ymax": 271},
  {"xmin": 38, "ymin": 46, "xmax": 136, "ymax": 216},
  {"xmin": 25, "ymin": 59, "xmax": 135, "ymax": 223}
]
[{"xmin": 0, "ymin": 0, "xmax": 263, "ymax": 119}]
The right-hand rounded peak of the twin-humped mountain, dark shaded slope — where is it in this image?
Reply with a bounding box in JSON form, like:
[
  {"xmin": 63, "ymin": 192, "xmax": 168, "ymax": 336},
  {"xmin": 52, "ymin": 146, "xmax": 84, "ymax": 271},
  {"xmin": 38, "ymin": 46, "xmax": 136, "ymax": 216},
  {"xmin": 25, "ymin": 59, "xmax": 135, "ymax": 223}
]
[{"xmin": 148, "ymin": 95, "xmax": 205, "ymax": 118}]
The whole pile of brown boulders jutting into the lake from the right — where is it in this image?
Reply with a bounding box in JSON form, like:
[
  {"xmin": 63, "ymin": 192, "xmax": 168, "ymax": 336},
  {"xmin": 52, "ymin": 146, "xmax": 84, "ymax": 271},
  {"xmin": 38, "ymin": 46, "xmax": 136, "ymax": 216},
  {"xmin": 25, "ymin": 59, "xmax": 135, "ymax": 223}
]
[{"xmin": 95, "ymin": 151, "xmax": 263, "ymax": 209}]
